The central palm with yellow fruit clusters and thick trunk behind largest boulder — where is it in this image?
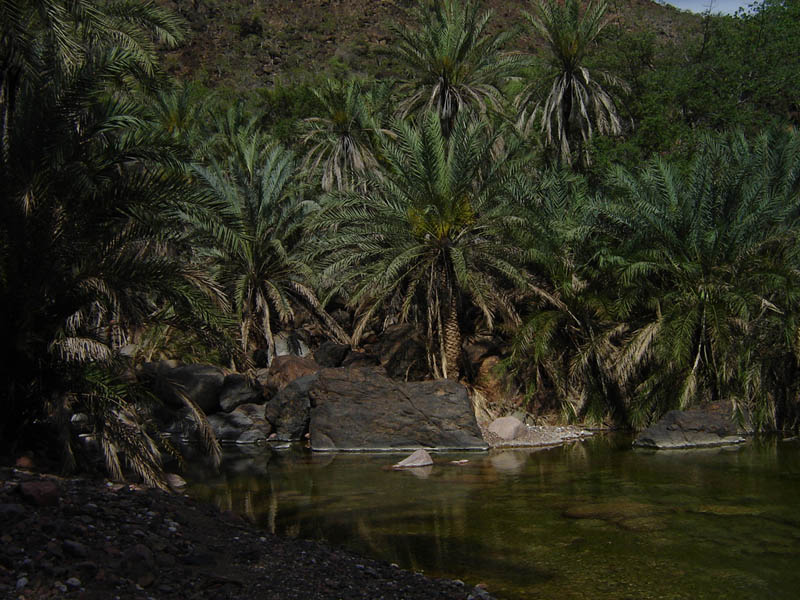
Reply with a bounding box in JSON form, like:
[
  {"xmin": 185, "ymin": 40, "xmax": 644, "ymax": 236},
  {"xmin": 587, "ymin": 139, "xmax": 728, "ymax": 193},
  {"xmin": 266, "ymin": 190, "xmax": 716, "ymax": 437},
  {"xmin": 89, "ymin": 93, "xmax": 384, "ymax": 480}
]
[{"xmin": 311, "ymin": 113, "xmax": 525, "ymax": 378}]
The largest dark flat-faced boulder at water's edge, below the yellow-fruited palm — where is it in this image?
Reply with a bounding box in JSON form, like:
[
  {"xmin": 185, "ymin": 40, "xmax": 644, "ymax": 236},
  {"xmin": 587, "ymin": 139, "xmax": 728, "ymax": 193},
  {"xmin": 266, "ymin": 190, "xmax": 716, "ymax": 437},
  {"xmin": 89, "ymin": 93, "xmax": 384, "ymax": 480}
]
[{"xmin": 308, "ymin": 369, "xmax": 487, "ymax": 450}]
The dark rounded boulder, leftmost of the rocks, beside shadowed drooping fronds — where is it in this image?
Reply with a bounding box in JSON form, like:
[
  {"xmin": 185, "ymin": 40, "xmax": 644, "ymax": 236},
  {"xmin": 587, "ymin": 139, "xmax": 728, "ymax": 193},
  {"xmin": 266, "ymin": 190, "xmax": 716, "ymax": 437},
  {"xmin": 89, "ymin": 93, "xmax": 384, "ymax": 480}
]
[{"xmin": 146, "ymin": 365, "xmax": 225, "ymax": 415}]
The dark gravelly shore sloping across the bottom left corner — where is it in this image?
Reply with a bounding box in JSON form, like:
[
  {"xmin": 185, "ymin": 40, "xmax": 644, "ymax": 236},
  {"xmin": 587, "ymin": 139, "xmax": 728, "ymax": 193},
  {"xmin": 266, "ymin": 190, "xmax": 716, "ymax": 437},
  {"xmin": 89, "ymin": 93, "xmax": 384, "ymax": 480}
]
[{"xmin": 0, "ymin": 467, "xmax": 489, "ymax": 600}]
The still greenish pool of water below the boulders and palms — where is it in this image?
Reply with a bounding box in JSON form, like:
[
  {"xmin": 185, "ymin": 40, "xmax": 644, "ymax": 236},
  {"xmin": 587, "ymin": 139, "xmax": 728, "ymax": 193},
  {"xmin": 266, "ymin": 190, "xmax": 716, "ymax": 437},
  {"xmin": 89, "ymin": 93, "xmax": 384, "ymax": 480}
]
[{"xmin": 184, "ymin": 436, "xmax": 800, "ymax": 600}]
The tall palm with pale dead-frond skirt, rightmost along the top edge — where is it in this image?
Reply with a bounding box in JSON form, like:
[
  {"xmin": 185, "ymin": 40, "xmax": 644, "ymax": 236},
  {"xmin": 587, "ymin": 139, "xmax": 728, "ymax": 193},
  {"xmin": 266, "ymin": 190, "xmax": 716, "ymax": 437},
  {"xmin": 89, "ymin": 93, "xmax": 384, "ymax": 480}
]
[{"xmin": 517, "ymin": 0, "xmax": 624, "ymax": 164}]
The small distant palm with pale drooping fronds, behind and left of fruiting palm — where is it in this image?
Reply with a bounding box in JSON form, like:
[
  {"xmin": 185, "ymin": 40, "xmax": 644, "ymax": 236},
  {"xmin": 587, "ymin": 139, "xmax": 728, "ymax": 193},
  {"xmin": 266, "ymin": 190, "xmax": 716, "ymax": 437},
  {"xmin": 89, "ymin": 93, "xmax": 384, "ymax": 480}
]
[{"xmin": 303, "ymin": 79, "xmax": 387, "ymax": 192}]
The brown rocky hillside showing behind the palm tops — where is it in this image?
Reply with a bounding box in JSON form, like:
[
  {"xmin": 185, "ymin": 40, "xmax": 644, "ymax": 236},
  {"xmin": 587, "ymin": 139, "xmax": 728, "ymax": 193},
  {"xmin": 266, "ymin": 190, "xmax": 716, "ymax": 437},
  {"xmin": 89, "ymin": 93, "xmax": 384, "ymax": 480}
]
[{"xmin": 159, "ymin": 0, "xmax": 698, "ymax": 91}]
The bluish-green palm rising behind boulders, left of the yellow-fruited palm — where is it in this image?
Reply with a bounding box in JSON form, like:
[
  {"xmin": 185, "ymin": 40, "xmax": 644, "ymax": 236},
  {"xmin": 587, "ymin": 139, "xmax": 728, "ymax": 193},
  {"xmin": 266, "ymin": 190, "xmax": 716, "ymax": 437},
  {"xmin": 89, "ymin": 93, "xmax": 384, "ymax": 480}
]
[{"xmin": 187, "ymin": 131, "xmax": 349, "ymax": 360}]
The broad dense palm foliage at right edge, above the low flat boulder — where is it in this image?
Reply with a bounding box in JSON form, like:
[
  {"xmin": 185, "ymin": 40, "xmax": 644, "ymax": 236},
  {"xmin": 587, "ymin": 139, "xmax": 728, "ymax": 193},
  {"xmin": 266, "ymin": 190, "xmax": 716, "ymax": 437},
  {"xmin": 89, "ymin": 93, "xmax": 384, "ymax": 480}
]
[{"xmin": 596, "ymin": 133, "xmax": 800, "ymax": 425}]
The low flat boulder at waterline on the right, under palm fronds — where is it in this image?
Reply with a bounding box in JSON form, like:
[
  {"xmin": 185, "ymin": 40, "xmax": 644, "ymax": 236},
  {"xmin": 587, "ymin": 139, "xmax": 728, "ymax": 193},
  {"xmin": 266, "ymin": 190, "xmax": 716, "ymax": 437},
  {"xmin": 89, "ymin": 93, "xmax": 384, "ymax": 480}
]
[{"xmin": 633, "ymin": 410, "xmax": 745, "ymax": 450}]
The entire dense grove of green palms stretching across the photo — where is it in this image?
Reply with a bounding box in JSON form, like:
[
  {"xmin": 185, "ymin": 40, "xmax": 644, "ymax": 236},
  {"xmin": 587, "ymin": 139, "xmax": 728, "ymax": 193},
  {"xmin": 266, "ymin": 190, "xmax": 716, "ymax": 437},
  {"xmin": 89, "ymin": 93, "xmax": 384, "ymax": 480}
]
[{"xmin": 0, "ymin": 0, "xmax": 800, "ymax": 483}]
